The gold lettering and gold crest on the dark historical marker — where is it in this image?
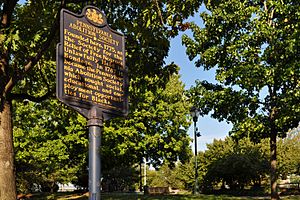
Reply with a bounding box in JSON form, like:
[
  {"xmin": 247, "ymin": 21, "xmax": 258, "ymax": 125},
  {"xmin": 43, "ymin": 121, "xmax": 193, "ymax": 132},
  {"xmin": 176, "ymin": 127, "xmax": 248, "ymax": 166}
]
[{"xmin": 63, "ymin": 13, "xmax": 124, "ymax": 109}]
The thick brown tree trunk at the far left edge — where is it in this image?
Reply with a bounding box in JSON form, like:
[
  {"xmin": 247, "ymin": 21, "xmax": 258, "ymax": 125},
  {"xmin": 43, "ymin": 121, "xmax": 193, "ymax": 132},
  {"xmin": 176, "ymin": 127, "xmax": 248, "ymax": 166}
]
[{"xmin": 0, "ymin": 101, "xmax": 17, "ymax": 200}]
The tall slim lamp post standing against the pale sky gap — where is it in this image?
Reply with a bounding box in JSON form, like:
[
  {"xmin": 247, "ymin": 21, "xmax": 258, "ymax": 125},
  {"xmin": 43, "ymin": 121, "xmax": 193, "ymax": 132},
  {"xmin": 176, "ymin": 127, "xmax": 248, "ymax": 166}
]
[{"xmin": 191, "ymin": 107, "xmax": 200, "ymax": 194}]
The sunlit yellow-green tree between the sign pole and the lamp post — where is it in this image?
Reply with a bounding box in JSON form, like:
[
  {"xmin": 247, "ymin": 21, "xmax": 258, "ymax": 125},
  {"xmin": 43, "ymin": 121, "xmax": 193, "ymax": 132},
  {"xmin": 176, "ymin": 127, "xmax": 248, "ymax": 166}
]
[{"xmin": 102, "ymin": 74, "xmax": 191, "ymax": 189}]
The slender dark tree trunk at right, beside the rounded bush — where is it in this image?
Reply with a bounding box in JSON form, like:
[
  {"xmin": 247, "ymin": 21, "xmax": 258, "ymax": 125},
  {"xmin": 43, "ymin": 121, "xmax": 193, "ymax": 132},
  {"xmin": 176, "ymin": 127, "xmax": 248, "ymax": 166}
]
[{"xmin": 270, "ymin": 131, "xmax": 279, "ymax": 200}]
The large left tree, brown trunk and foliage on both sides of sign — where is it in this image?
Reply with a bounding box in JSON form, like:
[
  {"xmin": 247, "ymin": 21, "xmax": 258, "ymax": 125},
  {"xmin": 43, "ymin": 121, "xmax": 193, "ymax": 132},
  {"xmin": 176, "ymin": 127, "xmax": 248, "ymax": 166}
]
[{"xmin": 0, "ymin": 0, "xmax": 201, "ymax": 197}]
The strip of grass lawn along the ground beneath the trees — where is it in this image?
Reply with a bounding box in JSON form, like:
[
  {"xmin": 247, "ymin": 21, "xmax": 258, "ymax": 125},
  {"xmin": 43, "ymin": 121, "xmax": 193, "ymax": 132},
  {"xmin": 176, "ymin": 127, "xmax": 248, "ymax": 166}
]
[{"xmin": 26, "ymin": 193, "xmax": 300, "ymax": 200}]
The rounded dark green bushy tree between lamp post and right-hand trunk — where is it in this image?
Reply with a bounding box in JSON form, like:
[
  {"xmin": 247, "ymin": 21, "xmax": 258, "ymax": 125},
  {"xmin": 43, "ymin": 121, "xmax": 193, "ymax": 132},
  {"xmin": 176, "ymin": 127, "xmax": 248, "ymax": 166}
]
[{"xmin": 204, "ymin": 137, "xmax": 269, "ymax": 190}]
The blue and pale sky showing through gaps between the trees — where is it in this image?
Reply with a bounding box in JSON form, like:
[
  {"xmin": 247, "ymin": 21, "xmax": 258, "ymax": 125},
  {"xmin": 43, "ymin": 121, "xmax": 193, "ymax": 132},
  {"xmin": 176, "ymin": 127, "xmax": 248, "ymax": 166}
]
[{"xmin": 165, "ymin": 11, "xmax": 232, "ymax": 152}]
